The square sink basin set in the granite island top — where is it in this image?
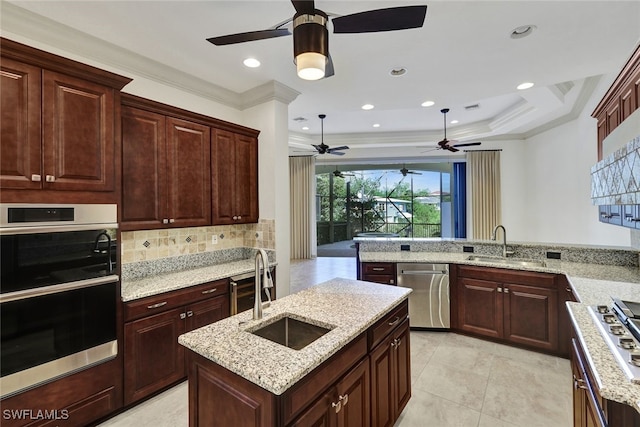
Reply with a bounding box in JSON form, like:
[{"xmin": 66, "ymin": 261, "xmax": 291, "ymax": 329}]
[{"xmin": 251, "ymin": 316, "xmax": 331, "ymax": 350}]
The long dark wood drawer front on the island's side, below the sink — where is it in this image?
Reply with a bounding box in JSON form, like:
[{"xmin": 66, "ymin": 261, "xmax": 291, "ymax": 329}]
[{"xmin": 282, "ymin": 334, "xmax": 367, "ymax": 425}]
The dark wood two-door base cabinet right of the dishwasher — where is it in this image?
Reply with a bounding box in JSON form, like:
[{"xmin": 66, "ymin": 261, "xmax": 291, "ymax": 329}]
[{"xmin": 457, "ymin": 265, "xmax": 558, "ymax": 353}]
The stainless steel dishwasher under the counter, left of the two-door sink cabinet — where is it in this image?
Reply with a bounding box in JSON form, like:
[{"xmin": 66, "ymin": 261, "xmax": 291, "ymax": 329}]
[{"xmin": 397, "ymin": 263, "xmax": 451, "ymax": 329}]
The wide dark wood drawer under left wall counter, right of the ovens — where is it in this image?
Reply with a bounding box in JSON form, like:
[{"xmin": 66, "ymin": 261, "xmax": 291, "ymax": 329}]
[{"xmin": 124, "ymin": 279, "xmax": 229, "ymax": 322}]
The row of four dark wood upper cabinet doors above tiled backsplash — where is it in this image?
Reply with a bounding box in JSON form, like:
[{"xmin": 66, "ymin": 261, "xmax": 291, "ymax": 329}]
[{"xmin": 121, "ymin": 94, "xmax": 258, "ymax": 230}]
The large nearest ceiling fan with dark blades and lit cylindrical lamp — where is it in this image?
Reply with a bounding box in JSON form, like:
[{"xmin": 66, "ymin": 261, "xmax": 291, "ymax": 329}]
[{"xmin": 207, "ymin": 0, "xmax": 427, "ymax": 80}]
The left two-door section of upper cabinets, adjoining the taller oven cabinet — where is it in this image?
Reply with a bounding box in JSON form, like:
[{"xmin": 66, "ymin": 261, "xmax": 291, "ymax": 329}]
[{"xmin": 121, "ymin": 100, "xmax": 211, "ymax": 230}]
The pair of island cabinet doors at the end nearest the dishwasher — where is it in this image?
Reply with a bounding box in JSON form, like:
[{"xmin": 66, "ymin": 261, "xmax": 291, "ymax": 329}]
[{"xmin": 369, "ymin": 320, "xmax": 411, "ymax": 427}]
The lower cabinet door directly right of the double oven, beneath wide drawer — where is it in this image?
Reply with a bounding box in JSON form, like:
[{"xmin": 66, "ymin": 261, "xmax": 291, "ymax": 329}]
[{"xmin": 124, "ymin": 308, "xmax": 186, "ymax": 405}]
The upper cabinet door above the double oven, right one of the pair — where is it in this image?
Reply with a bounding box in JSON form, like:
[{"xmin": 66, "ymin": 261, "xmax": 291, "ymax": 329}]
[{"xmin": 42, "ymin": 70, "xmax": 115, "ymax": 191}]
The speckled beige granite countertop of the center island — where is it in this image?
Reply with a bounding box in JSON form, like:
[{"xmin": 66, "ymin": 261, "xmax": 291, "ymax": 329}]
[{"xmin": 178, "ymin": 278, "xmax": 411, "ymax": 395}]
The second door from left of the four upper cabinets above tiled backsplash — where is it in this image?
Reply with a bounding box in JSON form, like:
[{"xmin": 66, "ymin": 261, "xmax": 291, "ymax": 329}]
[{"xmin": 166, "ymin": 117, "xmax": 211, "ymax": 227}]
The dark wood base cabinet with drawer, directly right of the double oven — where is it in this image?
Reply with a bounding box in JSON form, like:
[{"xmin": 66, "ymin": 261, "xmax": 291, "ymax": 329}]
[{"xmin": 124, "ymin": 280, "xmax": 230, "ymax": 405}]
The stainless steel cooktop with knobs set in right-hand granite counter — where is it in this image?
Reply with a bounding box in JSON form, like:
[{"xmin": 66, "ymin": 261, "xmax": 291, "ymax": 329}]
[{"xmin": 588, "ymin": 298, "xmax": 640, "ymax": 384}]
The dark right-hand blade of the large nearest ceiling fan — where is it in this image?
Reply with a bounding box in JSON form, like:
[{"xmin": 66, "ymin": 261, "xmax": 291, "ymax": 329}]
[{"xmin": 331, "ymin": 5, "xmax": 427, "ymax": 33}]
